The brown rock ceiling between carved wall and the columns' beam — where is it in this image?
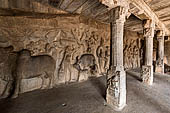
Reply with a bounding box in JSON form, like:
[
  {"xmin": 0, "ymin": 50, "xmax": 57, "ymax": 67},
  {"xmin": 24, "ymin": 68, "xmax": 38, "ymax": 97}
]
[{"xmin": 0, "ymin": 0, "xmax": 142, "ymax": 32}]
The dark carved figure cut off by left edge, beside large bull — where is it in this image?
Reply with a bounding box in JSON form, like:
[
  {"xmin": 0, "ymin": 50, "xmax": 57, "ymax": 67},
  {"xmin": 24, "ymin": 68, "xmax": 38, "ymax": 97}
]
[{"xmin": 0, "ymin": 46, "xmax": 17, "ymax": 98}]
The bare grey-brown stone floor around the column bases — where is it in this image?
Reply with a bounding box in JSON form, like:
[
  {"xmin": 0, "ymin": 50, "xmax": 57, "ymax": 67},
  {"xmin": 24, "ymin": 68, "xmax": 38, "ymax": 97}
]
[{"xmin": 0, "ymin": 73, "xmax": 170, "ymax": 113}]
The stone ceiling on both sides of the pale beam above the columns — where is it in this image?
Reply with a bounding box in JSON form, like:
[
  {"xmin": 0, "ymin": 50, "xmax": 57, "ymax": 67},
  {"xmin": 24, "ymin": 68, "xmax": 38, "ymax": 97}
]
[{"xmin": 0, "ymin": 0, "xmax": 170, "ymax": 32}]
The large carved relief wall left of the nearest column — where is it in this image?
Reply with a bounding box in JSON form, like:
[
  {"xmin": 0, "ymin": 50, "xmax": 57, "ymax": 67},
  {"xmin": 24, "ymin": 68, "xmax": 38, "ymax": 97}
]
[{"xmin": 0, "ymin": 18, "xmax": 110, "ymax": 97}]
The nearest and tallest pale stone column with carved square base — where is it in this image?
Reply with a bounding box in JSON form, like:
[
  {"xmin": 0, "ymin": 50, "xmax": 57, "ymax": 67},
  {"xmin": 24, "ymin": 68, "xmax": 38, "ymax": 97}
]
[{"xmin": 106, "ymin": 6, "xmax": 126, "ymax": 110}]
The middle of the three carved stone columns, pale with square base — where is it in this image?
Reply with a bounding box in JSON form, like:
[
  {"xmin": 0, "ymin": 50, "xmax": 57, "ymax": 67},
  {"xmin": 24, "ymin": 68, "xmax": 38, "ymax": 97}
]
[{"xmin": 142, "ymin": 20, "xmax": 155, "ymax": 85}]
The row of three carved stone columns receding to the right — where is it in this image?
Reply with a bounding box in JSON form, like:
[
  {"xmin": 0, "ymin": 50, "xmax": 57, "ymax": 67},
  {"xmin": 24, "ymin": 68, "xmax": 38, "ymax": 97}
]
[{"xmin": 106, "ymin": 6, "xmax": 164, "ymax": 110}]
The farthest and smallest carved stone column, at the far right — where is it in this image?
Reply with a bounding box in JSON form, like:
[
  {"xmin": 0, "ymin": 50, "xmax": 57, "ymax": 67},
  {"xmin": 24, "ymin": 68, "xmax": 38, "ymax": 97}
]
[{"xmin": 155, "ymin": 30, "xmax": 165, "ymax": 73}]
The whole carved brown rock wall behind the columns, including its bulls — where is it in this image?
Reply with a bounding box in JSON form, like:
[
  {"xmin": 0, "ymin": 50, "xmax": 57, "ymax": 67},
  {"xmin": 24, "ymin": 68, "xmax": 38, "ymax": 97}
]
[{"xmin": 0, "ymin": 16, "xmax": 144, "ymax": 96}]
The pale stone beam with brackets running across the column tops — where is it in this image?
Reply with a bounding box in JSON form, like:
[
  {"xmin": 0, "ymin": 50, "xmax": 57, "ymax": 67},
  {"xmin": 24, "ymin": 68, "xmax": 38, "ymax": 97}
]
[{"xmin": 99, "ymin": 0, "xmax": 170, "ymax": 35}]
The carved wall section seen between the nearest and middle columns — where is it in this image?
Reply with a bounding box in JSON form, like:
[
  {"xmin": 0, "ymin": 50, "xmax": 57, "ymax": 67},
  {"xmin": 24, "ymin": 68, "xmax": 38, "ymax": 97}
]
[{"xmin": 123, "ymin": 31, "xmax": 144, "ymax": 69}]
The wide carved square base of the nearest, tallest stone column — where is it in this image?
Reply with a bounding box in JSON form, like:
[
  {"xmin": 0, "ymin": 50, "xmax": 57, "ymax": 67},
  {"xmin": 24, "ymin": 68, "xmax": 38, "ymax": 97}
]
[{"xmin": 106, "ymin": 71, "xmax": 126, "ymax": 111}]
